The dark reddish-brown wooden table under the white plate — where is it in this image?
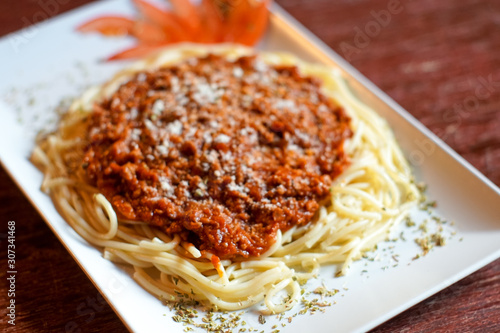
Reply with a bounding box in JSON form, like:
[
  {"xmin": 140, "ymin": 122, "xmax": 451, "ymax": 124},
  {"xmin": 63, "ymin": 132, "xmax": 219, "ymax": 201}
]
[{"xmin": 0, "ymin": 0, "xmax": 500, "ymax": 332}]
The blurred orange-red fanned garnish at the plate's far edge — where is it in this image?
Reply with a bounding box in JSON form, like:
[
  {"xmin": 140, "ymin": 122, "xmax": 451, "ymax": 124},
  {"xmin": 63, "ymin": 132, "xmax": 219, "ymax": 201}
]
[{"xmin": 77, "ymin": 0, "xmax": 271, "ymax": 60}]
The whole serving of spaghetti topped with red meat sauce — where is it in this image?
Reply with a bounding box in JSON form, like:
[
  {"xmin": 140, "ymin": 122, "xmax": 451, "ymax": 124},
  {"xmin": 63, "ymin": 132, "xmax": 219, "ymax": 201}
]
[{"xmin": 32, "ymin": 44, "xmax": 420, "ymax": 313}]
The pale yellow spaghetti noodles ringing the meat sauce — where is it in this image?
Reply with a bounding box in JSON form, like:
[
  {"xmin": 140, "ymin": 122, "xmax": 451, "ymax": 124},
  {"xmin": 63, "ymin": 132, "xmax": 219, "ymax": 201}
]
[{"xmin": 32, "ymin": 45, "xmax": 419, "ymax": 313}]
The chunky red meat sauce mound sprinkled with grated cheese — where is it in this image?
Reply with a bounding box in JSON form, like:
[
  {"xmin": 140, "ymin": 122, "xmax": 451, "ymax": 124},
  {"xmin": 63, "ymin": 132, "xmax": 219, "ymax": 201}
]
[{"xmin": 82, "ymin": 55, "xmax": 352, "ymax": 259}]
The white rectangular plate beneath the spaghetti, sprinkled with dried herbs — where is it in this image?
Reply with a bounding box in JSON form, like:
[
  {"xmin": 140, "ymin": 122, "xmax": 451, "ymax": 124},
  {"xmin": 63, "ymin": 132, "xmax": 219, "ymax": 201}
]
[{"xmin": 0, "ymin": 0, "xmax": 500, "ymax": 332}]
